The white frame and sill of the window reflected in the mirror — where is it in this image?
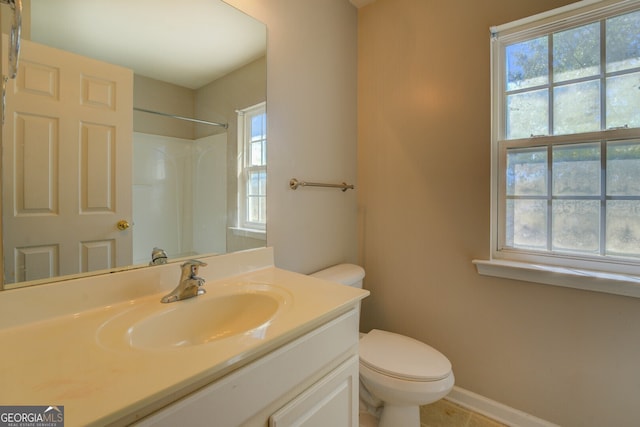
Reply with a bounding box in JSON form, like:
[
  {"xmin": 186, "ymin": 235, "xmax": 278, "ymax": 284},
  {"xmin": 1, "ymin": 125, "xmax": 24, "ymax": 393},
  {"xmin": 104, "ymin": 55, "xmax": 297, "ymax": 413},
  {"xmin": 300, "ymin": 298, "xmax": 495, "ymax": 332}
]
[{"xmin": 234, "ymin": 102, "xmax": 267, "ymax": 239}]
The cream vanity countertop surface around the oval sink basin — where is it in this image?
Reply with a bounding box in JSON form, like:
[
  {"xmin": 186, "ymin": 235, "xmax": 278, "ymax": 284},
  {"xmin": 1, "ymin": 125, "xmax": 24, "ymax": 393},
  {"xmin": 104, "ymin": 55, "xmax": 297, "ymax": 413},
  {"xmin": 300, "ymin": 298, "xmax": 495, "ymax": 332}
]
[{"xmin": 0, "ymin": 249, "xmax": 368, "ymax": 427}]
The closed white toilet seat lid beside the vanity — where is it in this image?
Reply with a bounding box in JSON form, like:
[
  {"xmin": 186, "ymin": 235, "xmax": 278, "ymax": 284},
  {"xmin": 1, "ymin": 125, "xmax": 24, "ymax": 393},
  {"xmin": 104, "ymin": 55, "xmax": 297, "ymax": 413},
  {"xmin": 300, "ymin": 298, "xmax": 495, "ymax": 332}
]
[{"xmin": 359, "ymin": 329, "xmax": 451, "ymax": 382}]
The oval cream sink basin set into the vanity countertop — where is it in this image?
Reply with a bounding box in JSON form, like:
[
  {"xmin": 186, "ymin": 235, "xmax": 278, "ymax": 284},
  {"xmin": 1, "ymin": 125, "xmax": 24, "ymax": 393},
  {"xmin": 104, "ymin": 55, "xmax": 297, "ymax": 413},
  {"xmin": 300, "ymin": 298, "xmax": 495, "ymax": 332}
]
[{"xmin": 98, "ymin": 285, "xmax": 290, "ymax": 350}]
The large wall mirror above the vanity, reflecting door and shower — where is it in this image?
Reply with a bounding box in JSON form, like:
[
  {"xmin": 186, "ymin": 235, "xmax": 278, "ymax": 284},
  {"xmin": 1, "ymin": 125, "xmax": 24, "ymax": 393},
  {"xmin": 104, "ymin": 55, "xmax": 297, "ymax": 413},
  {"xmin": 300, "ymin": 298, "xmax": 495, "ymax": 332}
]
[{"xmin": 0, "ymin": 0, "xmax": 266, "ymax": 289}]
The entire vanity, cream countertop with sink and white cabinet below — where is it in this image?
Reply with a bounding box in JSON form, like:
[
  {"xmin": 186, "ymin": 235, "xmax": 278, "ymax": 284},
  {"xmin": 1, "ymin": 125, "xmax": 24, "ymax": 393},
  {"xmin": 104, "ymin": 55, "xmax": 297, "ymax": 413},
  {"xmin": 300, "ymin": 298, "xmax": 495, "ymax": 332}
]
[{"xmin": 0, "ymin": 248, "xmax": 369, "ymax": 427}]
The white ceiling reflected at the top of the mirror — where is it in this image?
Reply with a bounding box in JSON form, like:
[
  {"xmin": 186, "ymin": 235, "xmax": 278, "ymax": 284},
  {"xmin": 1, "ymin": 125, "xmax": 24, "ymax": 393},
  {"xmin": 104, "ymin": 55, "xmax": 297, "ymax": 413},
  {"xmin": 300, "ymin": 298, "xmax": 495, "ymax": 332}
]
[{"xmin": 31, "ymin": 0, "xmax": 266, "ymax": 89}]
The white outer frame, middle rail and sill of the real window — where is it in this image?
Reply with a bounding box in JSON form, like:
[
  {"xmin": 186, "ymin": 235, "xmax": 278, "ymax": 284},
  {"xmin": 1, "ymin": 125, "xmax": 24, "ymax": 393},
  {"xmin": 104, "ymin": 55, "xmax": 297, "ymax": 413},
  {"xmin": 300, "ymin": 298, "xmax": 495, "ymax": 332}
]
[{"xmin": 473, "ymin": 0, "xmax": 640, "ymax": 297}]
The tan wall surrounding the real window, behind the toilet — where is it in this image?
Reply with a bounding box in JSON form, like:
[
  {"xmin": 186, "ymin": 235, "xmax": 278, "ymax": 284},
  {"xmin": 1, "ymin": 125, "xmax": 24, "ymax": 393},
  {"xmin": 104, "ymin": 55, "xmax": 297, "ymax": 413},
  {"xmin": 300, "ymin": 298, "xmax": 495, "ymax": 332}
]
[{"xmin": 358, "ymin": 0, "xmax": 640, "ymax": 427}]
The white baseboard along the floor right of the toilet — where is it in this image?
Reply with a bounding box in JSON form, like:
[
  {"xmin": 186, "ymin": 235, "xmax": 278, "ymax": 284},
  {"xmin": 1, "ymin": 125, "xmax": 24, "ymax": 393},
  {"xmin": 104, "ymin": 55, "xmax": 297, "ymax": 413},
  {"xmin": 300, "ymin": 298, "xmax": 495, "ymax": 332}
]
[{"xmin": 445, "ymin": 386, "xmax": 559, "ymax": 427}]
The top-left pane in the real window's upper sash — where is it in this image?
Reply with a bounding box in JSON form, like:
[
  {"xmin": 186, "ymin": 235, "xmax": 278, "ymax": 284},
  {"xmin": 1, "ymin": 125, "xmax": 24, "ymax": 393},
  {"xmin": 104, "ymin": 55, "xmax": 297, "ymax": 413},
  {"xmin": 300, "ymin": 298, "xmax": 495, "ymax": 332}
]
[{"xmin": 505, "ymin": 36, "xmax": 549, "ymax": 90}]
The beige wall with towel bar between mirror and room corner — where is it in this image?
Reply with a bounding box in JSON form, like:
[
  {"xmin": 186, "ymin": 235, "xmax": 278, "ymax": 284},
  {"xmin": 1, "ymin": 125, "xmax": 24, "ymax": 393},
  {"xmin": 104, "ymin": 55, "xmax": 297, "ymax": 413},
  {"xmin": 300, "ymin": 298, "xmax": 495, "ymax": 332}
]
[{"xmin": 227, "ymin": 0, "xmax": 357, "ymax": 273}]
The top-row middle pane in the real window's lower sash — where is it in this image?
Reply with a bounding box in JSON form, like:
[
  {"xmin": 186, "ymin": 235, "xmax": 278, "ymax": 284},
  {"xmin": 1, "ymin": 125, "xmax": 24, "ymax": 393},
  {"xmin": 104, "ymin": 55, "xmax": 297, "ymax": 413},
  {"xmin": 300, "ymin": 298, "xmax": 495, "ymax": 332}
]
[{"xmin": 553, "ymin": 144, "xmax": 601, "ymax": 196}]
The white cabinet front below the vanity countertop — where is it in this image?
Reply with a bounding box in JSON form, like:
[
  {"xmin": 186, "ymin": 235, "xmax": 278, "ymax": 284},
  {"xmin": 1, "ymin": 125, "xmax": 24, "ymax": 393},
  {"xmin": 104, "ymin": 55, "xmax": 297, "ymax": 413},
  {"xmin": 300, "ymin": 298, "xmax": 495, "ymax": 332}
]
[{"xmin": 136, "ymin": 304, "xmax": 359, "ymax": 427}]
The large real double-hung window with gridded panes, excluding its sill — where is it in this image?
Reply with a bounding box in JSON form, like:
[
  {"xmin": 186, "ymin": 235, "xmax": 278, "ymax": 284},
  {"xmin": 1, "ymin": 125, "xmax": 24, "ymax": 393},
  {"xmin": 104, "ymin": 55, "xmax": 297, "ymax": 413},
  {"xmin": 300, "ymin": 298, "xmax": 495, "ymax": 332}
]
[{"xmin": 479, "ymin": 0, "xmax": 640, "ymax": 296}]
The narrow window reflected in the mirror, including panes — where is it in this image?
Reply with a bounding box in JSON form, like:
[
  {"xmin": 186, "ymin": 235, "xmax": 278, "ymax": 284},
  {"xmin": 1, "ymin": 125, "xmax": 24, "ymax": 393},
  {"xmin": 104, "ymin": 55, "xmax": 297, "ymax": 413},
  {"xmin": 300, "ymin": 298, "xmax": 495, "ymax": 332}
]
[{"xmin": 238, "ymin": 103, "xmax": 267, "ymax": 230}]
